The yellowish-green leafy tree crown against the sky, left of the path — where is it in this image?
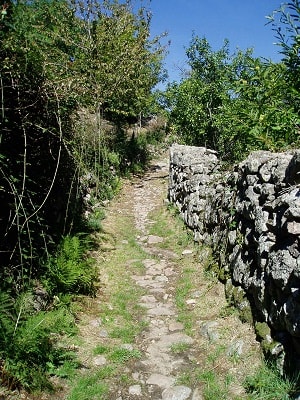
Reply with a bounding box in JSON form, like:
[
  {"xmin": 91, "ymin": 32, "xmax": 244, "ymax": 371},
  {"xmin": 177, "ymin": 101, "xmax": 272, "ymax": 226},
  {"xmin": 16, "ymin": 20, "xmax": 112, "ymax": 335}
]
[{"xmin": 66, "ymin": 0, "xmax": 165, "ymax": 120}]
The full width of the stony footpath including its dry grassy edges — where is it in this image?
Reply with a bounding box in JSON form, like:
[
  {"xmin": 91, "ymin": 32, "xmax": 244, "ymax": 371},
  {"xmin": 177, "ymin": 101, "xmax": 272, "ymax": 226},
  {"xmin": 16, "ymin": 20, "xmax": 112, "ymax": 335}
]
[{"xmin": 69, "ymin": 152, "xmax": 258, "ymax": 400}]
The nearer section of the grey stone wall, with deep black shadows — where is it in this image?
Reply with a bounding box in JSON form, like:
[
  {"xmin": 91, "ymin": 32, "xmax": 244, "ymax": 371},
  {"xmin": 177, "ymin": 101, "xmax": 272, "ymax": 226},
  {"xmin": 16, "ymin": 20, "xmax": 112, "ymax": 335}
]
[{"xmin": 233, "ymin": 152, "xmax": 300, "ymax": 355}]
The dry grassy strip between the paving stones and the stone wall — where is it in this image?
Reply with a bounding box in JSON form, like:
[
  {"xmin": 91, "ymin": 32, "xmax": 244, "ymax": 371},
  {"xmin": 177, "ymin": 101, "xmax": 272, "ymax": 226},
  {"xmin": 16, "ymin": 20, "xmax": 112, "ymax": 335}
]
[{"xmin": 146, "ymin": 207, "xmax": 270, "ymax": 400}]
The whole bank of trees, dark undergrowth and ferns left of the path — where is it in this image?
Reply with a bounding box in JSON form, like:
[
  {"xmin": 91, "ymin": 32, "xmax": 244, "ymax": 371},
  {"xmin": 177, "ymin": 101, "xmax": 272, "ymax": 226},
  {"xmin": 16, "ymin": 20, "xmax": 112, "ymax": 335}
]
[{"xmin": 0, "ymin": 0, "xmax": 165, "ymax": 390}]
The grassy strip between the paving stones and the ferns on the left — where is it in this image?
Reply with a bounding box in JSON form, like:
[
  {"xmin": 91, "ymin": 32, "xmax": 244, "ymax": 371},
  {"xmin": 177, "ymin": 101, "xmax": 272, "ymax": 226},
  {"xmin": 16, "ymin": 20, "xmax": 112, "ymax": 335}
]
[{"xmin": 61, "ymin": 188, "xmax": 149, "ymax": 400}]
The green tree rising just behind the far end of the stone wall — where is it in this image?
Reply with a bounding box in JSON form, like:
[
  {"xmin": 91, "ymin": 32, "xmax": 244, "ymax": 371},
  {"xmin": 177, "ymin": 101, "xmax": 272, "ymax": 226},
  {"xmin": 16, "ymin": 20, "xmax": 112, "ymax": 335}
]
[{"xmin": 168, "ymin": 36, "xmax": 229, "ymax": 148}]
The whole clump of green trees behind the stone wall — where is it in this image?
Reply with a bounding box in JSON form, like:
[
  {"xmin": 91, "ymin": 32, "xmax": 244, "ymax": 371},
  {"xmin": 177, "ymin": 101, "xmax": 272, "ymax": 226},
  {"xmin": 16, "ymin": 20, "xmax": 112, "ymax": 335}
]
[{"xmin": 166, "ymin": 33, "xmax": 299, "ymax": 161}]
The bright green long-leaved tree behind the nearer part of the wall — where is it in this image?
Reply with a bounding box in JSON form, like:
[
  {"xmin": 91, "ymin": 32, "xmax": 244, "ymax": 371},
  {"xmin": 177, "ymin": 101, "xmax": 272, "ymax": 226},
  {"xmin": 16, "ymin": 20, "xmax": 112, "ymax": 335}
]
[{"xmin": 216, "ymin": 57, "xmax": 298, "ymax": 159}]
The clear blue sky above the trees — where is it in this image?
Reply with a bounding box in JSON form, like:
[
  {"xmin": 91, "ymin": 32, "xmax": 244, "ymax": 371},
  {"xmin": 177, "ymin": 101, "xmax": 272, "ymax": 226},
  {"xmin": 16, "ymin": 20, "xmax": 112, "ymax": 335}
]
[{"xmin": 148, "ymin": 0, "xmax": 283, "ymax": 85}]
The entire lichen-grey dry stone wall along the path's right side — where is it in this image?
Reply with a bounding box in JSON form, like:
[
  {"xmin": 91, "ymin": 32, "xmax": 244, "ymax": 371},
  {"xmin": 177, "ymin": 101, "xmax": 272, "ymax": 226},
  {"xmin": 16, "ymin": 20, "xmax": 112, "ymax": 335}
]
[{"xmin": 168, "ymin": 145, "xmax": 300, "ymax": 364}]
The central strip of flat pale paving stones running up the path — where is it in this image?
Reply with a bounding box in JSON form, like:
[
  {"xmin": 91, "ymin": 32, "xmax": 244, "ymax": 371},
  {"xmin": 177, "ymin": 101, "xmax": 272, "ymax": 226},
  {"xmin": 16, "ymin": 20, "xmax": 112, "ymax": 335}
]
[{"xmin": 117, "ymin": 160, "xmax": 202, "ymax": 400}]
